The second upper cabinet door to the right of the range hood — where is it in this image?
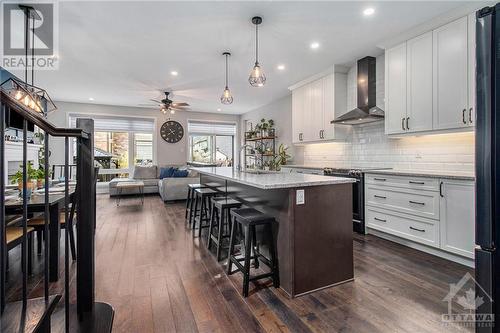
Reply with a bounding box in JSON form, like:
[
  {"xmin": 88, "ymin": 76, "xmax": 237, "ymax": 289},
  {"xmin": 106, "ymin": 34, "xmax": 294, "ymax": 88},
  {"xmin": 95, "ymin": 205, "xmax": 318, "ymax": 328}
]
[{"xmin": 405, "ymin": 32, "xmax": 432, "ymax": 132}]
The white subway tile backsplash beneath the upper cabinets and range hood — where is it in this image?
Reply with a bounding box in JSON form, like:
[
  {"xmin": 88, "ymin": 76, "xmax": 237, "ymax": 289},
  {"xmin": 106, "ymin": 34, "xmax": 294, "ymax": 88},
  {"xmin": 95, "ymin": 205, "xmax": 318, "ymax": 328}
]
[{"xmin": 297, "ymin": 122, "xmax": 474, "ymax": 172}]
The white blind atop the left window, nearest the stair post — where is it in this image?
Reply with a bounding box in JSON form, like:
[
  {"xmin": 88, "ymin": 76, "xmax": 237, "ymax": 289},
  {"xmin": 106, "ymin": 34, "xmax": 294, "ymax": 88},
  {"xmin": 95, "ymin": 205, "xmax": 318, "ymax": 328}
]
[{"xmin": 69, "ymin": 114, "xmax": 155, "ymax": 133}]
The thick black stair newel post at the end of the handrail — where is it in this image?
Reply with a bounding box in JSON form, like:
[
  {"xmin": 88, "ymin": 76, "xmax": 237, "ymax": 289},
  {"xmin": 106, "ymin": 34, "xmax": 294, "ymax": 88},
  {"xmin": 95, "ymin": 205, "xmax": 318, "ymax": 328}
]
[{"xmin": 75, "ymin": 118, "xmax": 96, "ymax": 319}]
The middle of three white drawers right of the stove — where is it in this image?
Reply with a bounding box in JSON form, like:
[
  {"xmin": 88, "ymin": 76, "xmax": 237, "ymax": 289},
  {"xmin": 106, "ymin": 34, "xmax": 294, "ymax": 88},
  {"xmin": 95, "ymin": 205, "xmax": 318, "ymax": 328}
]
[{"xmin": 365, "ymin": 185, "xmax": 439, "ymax": 220}]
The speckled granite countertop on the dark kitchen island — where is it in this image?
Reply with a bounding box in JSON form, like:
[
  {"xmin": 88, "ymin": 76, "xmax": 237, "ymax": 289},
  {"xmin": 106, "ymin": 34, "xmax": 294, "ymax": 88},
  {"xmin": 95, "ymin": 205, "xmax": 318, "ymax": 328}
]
[{"xmin": 192, "ymin": 167, "xmax": 355, "ymax": 190}]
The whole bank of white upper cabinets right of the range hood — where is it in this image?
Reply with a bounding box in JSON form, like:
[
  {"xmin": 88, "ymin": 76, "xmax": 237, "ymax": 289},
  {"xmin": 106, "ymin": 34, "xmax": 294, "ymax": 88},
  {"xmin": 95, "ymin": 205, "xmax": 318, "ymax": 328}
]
[{"xmin": 385, "ymin": 14, "xmax": 475, "ymax": 135}]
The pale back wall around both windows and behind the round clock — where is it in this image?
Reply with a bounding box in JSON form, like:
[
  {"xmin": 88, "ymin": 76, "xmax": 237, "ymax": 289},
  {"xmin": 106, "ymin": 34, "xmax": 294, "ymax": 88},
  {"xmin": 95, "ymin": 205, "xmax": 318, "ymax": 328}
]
[{"xmin": 48, "ymin": 102, "xmax": 240, "ymax": 165}]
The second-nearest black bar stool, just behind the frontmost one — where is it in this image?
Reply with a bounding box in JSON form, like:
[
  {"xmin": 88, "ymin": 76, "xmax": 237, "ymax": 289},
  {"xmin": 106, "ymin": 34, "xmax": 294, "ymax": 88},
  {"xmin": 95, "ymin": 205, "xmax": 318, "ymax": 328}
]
[{"xmin": 207, "ymin": 198, "xmax": 242, "ymax": 261}]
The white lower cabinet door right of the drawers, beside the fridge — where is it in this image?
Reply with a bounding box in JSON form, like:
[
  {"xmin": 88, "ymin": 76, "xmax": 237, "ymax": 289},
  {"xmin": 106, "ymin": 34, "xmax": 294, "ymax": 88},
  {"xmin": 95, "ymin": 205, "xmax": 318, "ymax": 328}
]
[{"xmin": 440, "ymin": 180, "xmax": 475, "ymax": 257}]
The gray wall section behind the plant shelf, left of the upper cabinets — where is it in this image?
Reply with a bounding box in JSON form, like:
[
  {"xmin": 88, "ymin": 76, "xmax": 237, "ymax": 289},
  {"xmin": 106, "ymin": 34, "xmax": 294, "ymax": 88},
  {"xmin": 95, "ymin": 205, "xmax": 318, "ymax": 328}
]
[{"xmin": 240, "ymin": 93, "xmax": 295, "ymax": 163}]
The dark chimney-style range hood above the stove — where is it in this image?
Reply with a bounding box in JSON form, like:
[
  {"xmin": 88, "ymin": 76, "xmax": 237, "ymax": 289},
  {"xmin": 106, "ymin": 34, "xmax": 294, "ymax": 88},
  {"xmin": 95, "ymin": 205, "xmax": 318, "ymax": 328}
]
[{"xmin": 331, "ymin": 57, "xmax": 384, "ymax": 125}]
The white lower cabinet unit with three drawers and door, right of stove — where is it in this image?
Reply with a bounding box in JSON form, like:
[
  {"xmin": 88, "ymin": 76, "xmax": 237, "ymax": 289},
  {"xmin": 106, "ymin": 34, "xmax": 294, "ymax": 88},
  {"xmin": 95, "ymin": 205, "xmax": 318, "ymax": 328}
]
[{"xmin": 365, "ymin": 174, "xmax": 475, "ymax": 260}]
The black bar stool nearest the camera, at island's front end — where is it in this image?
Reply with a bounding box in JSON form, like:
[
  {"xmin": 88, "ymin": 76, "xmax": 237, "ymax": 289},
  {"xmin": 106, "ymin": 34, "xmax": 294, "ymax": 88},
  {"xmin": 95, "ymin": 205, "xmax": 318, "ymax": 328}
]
[{"xmin": 227, "ymin": 208, "xmax": 279, "ymax": 297}]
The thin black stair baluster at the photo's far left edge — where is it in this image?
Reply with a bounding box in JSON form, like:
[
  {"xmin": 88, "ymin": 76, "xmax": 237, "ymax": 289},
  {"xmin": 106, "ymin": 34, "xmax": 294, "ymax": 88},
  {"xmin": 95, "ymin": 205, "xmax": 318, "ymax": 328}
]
[{"xmin": 0, "ymin": 100, "xmax": 7, "ymax": 315}]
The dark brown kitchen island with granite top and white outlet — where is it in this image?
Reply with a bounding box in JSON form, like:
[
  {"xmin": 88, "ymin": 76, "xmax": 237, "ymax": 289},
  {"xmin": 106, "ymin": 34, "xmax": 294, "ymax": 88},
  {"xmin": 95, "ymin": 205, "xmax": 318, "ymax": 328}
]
[{"xmin": 193, "ymin": 167, "xmax": 355, "ymax": 297}]
